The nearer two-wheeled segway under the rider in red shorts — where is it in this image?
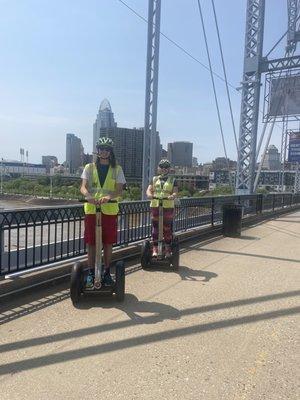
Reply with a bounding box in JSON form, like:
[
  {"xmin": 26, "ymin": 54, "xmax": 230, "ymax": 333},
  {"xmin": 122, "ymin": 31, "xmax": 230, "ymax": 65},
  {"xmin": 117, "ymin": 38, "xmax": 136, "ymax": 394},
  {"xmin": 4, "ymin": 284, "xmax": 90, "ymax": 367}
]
[{"xmin": 70, "ymin": 200, "xmax": 125, "ymax": 306}]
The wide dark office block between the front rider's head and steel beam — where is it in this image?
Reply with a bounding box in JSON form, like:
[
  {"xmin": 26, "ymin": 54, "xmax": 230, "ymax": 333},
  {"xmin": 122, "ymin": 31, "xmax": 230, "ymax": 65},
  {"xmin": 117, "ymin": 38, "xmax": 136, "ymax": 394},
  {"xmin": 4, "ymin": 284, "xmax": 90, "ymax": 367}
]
[{"xmin": 100, "ymin": 127, "xmax": 161, "ymax": 183}]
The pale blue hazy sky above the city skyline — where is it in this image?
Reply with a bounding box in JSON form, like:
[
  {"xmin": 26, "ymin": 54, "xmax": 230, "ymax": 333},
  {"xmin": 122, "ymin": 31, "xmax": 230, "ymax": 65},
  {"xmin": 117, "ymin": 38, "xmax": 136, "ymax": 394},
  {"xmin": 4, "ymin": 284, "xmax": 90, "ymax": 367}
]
[{"xmin": 0, "ymin": 0, "xmax": 287, "ymax": 163}]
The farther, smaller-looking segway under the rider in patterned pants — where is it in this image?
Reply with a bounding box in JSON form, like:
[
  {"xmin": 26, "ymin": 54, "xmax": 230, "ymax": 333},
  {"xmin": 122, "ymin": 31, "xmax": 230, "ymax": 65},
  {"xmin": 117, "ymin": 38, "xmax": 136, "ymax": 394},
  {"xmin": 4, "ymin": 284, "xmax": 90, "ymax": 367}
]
[{"xmin": 141, "ymin": 197, "xmax": 179, "ymax": 270}]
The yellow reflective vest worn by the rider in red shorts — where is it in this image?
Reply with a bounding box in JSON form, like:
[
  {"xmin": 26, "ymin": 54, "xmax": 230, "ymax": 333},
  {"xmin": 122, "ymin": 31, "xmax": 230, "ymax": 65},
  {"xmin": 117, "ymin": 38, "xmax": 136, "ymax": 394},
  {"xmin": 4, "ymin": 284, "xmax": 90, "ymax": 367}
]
[{"xmin": 84, "ymin": 163, "xmax": 121, "ymax": 215}]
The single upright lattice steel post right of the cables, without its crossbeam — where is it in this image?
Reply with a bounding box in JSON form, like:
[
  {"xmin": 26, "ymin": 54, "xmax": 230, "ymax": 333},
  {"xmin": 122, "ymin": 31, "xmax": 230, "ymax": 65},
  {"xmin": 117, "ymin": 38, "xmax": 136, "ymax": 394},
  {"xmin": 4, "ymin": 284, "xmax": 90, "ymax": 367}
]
[{"xmin": 236, "ymin": 0, "xmax": 265, "ymax": 194}]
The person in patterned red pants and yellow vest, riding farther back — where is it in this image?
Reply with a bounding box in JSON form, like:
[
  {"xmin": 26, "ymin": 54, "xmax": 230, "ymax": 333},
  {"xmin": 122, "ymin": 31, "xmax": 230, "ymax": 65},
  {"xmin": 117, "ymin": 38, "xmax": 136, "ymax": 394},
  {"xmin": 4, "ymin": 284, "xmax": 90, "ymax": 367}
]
[{"xmin": 146, "ymin": 158, "xmax": 178, "ymax": 257}]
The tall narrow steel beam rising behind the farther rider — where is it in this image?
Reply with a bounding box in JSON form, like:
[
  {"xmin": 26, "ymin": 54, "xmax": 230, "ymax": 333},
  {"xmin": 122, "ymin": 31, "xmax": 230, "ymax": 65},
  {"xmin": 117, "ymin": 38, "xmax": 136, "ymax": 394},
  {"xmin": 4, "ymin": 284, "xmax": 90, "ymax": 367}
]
[{"xmin": 142, "ymin": 0, "xmax": 161, "ymax": 199}]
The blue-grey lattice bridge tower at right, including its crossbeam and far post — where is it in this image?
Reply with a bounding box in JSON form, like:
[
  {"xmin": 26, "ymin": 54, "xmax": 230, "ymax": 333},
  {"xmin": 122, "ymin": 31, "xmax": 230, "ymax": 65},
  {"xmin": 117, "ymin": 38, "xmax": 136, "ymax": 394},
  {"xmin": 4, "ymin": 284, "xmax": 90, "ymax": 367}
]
[{"xmin": 236, "ymin": 0, "xmax": 300, "ymax": 194}]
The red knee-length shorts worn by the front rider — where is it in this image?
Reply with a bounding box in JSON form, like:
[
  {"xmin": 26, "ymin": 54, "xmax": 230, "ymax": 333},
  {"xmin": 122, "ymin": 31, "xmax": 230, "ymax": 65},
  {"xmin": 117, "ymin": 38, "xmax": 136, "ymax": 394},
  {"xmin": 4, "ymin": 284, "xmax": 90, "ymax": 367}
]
[{"xmin": 84, "ymin": 214, "xmax": 117, "ymax": 246}]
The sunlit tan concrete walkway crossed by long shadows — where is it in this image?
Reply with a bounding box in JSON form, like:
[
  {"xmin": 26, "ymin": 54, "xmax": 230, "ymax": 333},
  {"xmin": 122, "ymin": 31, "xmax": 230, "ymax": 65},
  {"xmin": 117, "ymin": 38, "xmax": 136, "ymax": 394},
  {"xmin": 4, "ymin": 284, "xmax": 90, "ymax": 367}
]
[{"xmin": 0, "ymin": 212, "xmax": 300, "ymax": 400}]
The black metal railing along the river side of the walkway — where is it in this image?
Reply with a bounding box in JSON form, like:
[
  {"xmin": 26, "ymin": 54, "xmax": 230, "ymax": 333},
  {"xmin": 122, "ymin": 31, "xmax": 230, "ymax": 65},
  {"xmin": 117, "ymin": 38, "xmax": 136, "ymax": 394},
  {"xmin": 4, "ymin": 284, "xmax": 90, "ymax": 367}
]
[{"xmin": 0, "ymin": 193, "xmax": 300, "ymax": 276}]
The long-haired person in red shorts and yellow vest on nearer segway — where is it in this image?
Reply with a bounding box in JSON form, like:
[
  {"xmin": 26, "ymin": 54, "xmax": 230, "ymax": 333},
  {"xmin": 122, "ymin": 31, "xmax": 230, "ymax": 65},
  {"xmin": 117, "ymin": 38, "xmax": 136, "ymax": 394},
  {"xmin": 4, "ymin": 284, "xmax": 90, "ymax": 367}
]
[{"xmin": 80, "ymin": 137, "xmax": 126, "ymax": 287}]
